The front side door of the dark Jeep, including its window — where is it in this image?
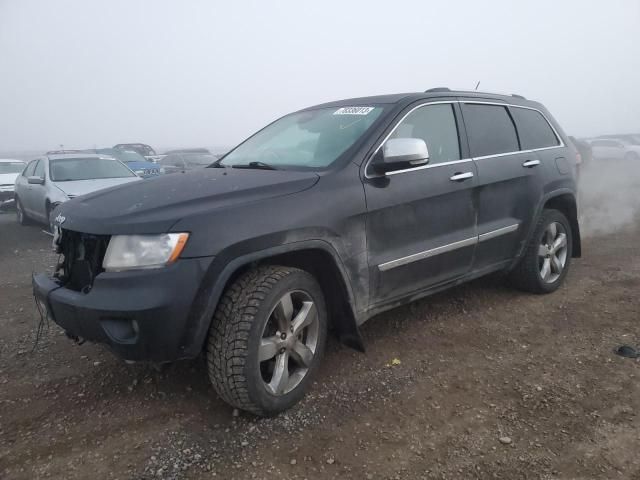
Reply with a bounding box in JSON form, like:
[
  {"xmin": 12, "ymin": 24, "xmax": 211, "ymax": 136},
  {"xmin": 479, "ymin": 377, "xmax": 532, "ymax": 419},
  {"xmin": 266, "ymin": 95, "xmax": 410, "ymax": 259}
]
[{"xmin": 364, "ymin": 103, "xmax": 477, "ymax": 304}]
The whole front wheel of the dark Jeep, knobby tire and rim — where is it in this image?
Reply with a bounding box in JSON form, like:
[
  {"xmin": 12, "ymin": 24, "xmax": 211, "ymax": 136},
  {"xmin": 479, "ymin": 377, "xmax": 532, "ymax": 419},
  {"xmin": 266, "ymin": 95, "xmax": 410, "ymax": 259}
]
[{"xmin": 207, "ymin": 266, "xmax": 327, "ymax": 416}]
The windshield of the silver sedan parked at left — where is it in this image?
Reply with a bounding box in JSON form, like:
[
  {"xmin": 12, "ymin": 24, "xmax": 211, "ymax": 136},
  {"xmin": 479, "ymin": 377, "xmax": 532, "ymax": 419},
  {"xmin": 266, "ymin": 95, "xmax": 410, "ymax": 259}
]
[{"xmin": 49, "ymin": 157, "xmax": 136, "ymax": 182}]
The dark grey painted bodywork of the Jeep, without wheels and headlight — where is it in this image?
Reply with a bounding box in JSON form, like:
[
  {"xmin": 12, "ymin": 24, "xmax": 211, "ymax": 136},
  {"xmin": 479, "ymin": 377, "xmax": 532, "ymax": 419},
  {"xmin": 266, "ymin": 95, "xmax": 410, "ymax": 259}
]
[{"xmin": 33, "ymin": 91, "xmax": 579, "ymax": 362}]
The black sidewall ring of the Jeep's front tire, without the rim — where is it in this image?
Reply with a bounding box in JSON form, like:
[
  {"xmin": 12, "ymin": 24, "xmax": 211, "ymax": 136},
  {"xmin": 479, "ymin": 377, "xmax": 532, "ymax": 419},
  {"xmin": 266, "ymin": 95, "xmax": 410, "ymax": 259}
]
[{"xmin": 244, "ymin": 271, "xmax": 327, "ymax": 415}]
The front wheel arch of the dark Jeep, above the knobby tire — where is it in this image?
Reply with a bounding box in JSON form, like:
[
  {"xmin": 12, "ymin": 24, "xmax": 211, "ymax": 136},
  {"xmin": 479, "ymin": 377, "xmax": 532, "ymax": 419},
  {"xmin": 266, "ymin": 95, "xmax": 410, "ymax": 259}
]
[{"xmin": 189, "ymin": 240, "xmax": 364, "ymax": 356}]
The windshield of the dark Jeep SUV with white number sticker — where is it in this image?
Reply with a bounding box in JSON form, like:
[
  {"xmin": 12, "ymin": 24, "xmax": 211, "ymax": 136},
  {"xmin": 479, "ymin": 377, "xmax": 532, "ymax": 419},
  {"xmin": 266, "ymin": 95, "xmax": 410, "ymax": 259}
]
[{"xmin": 220, "ymin": 107, "xmax": 382, "ymax": 168}]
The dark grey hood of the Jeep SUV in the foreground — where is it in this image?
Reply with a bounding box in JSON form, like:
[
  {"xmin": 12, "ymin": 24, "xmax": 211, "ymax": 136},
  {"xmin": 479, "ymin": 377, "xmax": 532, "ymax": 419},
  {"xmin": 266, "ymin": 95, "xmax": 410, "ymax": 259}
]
[{"xmin": 58, "ymin": 168, "xmax": 319, "ymax": 235}]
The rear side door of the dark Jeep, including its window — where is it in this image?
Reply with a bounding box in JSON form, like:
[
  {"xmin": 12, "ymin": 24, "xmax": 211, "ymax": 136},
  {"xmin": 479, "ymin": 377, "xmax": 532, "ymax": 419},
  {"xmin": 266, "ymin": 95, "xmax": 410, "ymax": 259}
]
[{"xmin": 462, "ymin": 101, "xmax": 544, "ymax": 271}]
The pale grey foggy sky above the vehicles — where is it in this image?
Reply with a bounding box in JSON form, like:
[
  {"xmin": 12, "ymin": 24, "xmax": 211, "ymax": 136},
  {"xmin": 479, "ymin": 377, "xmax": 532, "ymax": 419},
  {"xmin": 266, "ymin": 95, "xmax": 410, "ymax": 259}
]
[{"xmin": 0, "ymin": 0, "xmax": 640, "ymax": 151}]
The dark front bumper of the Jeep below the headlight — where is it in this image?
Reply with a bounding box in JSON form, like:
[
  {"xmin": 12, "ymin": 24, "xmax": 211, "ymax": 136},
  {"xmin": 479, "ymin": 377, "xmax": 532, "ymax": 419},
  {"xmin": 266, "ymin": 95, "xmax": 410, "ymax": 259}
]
[{"xmin": 32, "ymin": 257, "xmax": 213, "ymax": 362}]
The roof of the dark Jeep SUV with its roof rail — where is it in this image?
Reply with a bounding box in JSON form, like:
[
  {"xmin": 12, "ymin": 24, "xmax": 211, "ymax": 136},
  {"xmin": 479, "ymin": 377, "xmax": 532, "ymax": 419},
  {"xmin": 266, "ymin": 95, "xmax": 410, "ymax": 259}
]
[{"xmin": 304, "ymin": 88, "xmax": 540, "ymax": 110}]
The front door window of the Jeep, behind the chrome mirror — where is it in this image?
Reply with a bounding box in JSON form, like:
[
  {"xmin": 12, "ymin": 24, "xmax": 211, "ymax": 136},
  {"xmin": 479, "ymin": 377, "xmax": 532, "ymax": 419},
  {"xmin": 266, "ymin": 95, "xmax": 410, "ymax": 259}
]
[{"xmin": 389, "ymin": 104, "xmax": 460, "ymax": 164}]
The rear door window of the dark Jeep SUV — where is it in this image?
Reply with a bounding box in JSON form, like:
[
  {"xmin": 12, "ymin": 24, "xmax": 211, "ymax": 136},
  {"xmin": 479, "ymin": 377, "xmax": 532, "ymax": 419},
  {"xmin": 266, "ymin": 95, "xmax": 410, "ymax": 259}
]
[{"xmin": 463, "ymin": 103, "xmax": 520, "ymax": 157}]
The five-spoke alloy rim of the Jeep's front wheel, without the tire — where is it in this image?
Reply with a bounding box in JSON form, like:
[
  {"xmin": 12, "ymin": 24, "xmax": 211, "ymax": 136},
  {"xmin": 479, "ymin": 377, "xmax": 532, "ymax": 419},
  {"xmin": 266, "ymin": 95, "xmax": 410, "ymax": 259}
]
[{"xmin": 258, "ymin": 290, "xmax": 320, "ymax": 396}]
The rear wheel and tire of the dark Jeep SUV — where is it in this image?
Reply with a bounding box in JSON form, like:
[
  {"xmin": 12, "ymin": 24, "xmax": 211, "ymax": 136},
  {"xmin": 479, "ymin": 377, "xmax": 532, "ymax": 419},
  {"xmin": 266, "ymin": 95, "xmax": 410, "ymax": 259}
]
[{"xmin": 509, "ymin": 209, "xmax": 573, "ymax": 294}]
